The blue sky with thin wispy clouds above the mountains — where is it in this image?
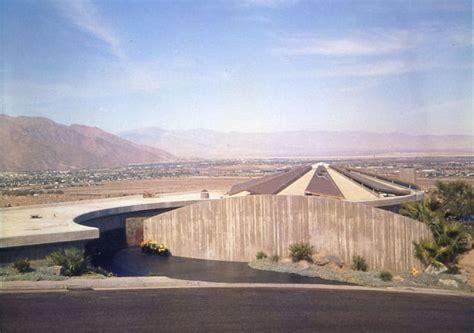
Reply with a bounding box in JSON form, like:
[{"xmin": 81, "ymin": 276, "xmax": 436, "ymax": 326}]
[{"xmin": 0, "ymin": 0, "xmax": 474, "ymax": 135}]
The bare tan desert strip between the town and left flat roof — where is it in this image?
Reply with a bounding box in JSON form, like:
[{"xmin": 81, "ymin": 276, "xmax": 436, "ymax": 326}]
[{"xmin": 0, "ymin": 177, "xmax": 248, "ymax": 207}]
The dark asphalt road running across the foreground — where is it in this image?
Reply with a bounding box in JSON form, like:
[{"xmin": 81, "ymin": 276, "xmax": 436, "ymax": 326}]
[{"xmin": 0, "ymin": 288, "xmax": 474, "ymax": 333}]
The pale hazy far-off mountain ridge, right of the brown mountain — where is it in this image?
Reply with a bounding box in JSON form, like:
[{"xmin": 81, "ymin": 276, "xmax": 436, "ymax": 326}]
[{"xmin": 118, "ymin": 127, "xmax": 474, "ymax": 158}]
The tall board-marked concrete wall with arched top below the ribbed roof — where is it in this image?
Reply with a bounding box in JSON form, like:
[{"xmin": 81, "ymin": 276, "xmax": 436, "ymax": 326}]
[{"xmin": 144, "ymin": 196, "xmax": 431, "ymax": 271}]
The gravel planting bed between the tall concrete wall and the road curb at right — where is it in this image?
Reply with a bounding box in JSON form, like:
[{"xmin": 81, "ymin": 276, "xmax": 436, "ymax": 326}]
[{"xmin": 249, "ymin": 259, "xmax": 474, "ymax": 292}]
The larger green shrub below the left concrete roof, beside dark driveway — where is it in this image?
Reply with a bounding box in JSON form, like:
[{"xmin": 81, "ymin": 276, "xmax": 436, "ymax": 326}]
[{"xmin": 46, "ymin": 247, "xmax": 88, "ymax": 276}]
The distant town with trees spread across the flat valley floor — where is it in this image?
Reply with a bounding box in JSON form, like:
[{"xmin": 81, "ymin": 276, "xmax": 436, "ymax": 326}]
[{"xmin": 0, "ymin": 157, "xmax": 474, "ymax": 196}]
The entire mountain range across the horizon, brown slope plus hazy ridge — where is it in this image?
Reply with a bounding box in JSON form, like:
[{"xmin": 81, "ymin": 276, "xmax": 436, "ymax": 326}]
[{"xmin": 0, "ymin": 115, "xmax": 474, "ymax": 171}]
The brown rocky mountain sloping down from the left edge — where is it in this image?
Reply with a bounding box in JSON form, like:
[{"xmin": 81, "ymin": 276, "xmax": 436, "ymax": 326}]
[{"xmin": 0, "ymin": 115, "xmax": 175, "ymax": 171}]
